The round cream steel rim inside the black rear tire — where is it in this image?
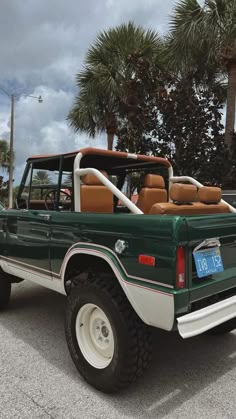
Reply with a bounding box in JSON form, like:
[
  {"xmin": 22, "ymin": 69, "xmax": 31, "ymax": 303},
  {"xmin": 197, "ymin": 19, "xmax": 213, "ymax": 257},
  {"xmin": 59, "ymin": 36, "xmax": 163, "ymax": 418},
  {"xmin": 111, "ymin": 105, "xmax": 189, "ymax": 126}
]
[{"xmin": 75, "ymin": 304, "xmax": 114, "ymax": 369}]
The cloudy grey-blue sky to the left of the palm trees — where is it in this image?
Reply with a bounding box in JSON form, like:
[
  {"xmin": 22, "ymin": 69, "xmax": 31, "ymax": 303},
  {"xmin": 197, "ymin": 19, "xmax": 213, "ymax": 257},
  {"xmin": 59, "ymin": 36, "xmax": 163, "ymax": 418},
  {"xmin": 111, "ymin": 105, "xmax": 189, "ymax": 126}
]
[{"xmin": 0, "ymin": 0, "xmax": 175, "ymax": 184}]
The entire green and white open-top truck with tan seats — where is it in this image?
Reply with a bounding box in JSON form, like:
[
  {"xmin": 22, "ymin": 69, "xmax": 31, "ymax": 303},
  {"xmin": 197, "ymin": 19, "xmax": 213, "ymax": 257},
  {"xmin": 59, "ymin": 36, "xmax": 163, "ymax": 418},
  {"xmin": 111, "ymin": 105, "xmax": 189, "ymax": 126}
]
[{"xmin": 0, "ymin": 148, "xmax": 236, "ymax": 392}]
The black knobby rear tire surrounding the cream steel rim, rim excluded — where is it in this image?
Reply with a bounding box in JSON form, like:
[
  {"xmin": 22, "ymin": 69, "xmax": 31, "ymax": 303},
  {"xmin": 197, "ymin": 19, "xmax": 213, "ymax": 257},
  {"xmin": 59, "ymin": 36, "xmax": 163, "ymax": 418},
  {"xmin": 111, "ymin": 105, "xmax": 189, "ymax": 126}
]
[{"xmin": 65, "ymin": 274, "xmax": 152, "ymax": 393}]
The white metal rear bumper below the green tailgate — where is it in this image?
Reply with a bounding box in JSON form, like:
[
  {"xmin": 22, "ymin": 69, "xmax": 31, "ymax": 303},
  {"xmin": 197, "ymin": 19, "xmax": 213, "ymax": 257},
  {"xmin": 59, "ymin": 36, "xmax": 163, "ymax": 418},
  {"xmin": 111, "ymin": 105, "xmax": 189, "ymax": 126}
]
[{"xmin": 177, "ymin": 295, "xmax": 236, "ymax": 339}]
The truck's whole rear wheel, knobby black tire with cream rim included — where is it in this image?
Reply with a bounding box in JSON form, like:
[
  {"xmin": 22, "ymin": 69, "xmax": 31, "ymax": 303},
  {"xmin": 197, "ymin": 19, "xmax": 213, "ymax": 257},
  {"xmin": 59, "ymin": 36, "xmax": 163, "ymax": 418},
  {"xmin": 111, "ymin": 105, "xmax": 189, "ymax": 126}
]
[{"xmin": 65, "ymin": 273, "xmax": 151, "ymax": 393}]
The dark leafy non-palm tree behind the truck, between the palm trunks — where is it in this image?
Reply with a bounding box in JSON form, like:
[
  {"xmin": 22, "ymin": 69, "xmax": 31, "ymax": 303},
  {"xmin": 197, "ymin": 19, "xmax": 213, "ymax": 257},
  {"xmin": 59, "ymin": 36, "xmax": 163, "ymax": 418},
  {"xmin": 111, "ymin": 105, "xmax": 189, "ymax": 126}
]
[{"xmin": 117, "ymin": 71, "xmax": 226, "ymax": 185}]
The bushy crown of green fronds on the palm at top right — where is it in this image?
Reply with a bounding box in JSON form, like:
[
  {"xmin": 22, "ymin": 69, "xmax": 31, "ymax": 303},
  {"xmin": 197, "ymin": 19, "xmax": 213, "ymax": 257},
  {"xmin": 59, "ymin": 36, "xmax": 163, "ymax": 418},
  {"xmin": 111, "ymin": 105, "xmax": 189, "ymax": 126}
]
[{"xmin": 166, "ymin": 0, "xmax": 236, "ymax": 77}]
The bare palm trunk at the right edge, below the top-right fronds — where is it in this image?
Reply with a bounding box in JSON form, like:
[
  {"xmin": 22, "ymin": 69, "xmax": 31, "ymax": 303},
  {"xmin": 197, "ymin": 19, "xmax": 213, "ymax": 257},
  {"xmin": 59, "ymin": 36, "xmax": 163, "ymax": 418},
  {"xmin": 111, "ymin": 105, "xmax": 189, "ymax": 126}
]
[{"xmin": 225, "ymin": 61, "xmax": 236, "ymax": 151}]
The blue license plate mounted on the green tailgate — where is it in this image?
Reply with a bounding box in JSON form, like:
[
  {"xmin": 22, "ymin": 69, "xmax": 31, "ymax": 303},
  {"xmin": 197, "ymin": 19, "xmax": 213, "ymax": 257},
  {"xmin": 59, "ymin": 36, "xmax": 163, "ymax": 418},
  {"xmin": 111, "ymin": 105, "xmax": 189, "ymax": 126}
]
[{"xmin": 193, "ymin": 247, "xmax": 224, "ymax": 278}]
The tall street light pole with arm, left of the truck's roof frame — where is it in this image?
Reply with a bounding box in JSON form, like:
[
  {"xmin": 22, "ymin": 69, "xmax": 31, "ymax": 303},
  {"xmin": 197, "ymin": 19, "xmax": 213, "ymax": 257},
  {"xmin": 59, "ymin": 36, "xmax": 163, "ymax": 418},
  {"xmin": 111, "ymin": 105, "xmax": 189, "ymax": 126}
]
[{"xmin": 0, "ymin": 87, "xmax": 43, "ymax": 208}]
